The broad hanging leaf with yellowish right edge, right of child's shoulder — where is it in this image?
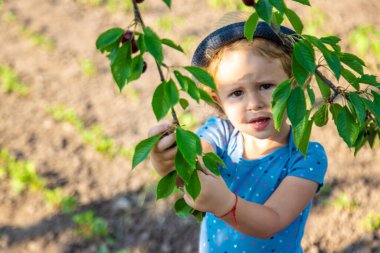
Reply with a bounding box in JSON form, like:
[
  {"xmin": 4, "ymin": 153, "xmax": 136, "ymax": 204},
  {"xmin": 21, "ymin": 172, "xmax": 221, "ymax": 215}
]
[{"xmin": 335, "ymin": 106, "xmax": 359, "ymax": 147}]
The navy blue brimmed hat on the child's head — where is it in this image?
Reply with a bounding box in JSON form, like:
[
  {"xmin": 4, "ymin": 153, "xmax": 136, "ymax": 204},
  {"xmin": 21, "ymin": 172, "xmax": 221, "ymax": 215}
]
[{"xmin": 191, "ymin": 13, "xmax": 296, "ymax": 67}]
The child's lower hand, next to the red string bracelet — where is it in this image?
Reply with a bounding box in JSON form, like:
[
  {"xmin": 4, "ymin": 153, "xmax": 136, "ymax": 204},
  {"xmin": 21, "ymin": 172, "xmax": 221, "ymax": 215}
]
[{"xmin": 184, "ymin": 169, "xmax": 235, "ymax": 216}]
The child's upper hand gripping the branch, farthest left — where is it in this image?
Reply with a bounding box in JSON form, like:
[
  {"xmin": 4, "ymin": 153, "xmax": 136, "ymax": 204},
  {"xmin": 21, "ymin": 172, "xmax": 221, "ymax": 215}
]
[{"xmin": 149, "ymin": 123, "xmax": 177, "ymax": 176}]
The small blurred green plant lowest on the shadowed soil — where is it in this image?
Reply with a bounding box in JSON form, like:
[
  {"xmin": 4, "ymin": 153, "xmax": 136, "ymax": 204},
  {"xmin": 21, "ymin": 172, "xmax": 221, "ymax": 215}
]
[{"xmin": 73, "ymin": 210, "xmax": 109, "ymax": 240}]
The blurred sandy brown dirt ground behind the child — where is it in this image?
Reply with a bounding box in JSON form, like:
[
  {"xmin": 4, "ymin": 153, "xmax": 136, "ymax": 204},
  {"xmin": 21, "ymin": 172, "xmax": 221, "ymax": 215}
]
[{"xmin": 0, "ymin": 0, "xmax": 380, "ymax": 253}]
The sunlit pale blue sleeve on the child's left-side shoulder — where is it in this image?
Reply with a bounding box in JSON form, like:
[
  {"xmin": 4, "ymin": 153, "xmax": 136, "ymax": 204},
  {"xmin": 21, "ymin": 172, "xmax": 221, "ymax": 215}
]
[{"xmin": 196, "ymin": 116, "xmax": 232, "ymax": 156}]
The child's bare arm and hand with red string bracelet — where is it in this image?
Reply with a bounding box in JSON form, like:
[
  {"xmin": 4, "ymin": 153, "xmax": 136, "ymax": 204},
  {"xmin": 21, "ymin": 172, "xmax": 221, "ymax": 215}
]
[{"xmin": 185, "ymin": 140, "xmax": 318, "ymax": 238}]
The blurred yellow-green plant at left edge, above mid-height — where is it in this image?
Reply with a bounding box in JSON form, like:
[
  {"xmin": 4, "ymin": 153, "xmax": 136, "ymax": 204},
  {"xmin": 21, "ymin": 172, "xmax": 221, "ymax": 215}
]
[{"xmin": 0, "ymin": 65, "xmax": 29, "ymax": 96}]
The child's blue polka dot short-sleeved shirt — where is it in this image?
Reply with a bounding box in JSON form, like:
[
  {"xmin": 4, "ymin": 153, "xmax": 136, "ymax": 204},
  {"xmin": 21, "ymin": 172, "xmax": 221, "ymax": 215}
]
[{"xmin": 197, "ymin": 116, "xmax": 327, "ymax": 253}]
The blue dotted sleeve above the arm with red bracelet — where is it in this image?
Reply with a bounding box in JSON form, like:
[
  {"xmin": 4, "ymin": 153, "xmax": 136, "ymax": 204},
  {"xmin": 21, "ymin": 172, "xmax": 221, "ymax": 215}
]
[{"xmin": 288, "ymin": 142, "xmax": 328, "ymax": 192}]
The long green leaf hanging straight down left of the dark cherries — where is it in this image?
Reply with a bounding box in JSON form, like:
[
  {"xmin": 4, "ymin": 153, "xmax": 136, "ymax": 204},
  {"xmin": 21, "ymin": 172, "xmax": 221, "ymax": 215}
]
[{"xmin": 111, "ymin": 41, "xmax": 132, "ymax": 91}]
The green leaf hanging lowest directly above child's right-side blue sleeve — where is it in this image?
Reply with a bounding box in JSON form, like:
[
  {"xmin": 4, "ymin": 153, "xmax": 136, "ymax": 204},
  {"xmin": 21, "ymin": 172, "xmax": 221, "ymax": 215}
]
[{"xmin": 293, "ymin": 111, "xmax": 313, "ymax": 155}]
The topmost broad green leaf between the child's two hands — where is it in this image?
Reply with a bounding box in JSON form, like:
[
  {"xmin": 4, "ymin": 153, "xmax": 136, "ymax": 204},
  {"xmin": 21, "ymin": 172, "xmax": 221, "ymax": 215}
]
[{"xmin": 176, "ymin": 127, "xmax": 202, "ymax": 166}]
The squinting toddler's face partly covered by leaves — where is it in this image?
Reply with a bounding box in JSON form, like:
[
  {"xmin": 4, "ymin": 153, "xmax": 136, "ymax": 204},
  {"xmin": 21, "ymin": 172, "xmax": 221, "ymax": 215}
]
[{"xmin": 215, "ymin": 49, "xmax": 289, "ymax": 139}]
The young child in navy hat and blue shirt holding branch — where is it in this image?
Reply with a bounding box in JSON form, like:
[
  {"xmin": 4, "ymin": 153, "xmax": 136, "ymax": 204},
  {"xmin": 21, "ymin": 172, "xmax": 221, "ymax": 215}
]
[{"xmin": 149, "ymin": 11, "xmax": 327, "ymax": 253}]
